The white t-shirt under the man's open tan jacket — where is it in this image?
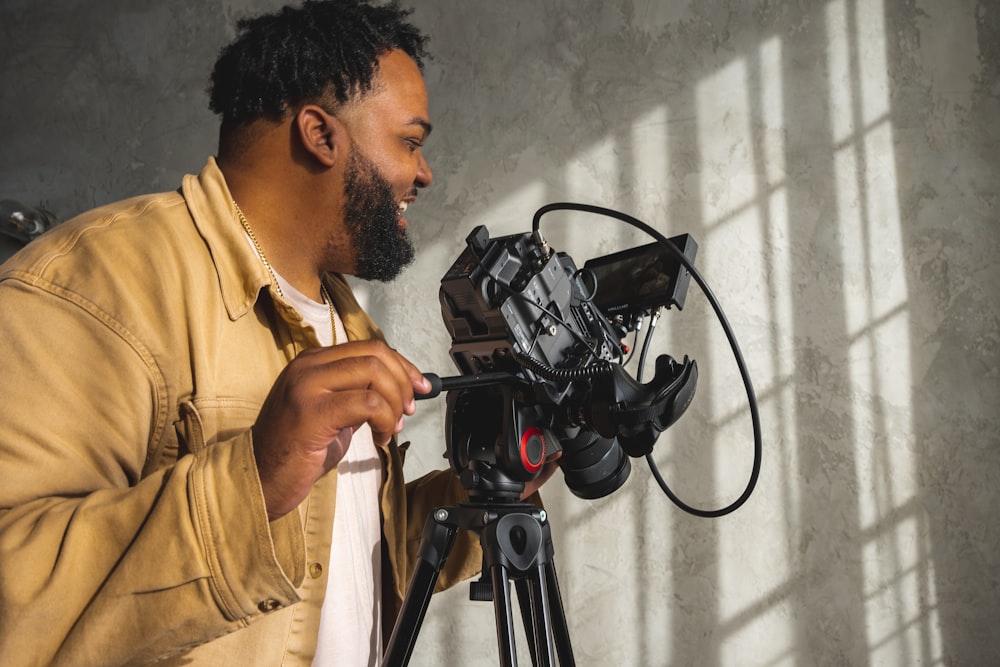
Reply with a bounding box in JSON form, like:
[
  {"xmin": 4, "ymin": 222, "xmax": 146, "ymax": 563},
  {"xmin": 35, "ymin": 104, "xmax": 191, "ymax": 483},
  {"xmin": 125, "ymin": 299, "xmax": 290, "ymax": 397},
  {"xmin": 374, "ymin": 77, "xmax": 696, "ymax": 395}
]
[{"xmin": 275, "ymin": 268, "xmax": 382, "ymax": 667}]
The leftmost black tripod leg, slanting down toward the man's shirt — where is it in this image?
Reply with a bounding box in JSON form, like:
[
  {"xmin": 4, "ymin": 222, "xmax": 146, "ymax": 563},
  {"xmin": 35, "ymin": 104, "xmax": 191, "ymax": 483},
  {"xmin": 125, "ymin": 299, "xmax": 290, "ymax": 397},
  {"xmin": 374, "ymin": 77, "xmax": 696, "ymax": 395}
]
[{"xmin": 383, "ymin": 510, "xmax": 458, "ymax": 667}]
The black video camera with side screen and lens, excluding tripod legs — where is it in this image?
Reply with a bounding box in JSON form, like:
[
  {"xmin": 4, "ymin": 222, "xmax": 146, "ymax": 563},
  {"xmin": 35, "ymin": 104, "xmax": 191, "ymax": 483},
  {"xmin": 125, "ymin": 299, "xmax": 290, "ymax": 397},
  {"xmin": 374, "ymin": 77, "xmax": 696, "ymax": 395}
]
[{"xmin": 427, "ymin": 226, "xmax": 698, "ymax": 500}]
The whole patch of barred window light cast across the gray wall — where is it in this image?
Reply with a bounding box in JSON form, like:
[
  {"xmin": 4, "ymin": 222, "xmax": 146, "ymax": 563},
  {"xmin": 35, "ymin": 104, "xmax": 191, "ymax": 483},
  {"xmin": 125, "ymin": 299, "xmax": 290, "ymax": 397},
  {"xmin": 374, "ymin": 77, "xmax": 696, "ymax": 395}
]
[{"xmin": 388, "ymin": 0, "xmax": 945, "ymax": 667}]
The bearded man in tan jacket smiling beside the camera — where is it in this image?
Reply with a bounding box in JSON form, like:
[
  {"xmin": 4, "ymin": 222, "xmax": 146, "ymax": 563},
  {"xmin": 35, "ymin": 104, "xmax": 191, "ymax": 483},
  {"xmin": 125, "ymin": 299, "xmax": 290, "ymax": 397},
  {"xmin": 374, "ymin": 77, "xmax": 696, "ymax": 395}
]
[{"xmin": 0, "ymin": 0, "xmax": 556, "ymax": 666}]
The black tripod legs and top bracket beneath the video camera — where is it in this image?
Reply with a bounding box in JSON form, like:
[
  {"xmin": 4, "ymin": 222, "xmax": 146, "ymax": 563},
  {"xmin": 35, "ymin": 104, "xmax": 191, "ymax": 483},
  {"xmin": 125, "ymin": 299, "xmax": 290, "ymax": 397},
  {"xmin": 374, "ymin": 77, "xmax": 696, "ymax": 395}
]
[{"xmin": 384, "ymin": 502, "xmax": 575, "ymax": 667}]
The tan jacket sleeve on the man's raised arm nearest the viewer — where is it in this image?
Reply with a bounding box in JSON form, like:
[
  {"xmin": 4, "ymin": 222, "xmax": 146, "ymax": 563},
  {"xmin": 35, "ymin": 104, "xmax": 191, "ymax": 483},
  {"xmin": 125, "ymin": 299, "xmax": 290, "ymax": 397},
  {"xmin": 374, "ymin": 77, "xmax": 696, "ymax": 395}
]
[{"xmin": 0, "ymin": 280, "xmax": 303, "ymax": 665}]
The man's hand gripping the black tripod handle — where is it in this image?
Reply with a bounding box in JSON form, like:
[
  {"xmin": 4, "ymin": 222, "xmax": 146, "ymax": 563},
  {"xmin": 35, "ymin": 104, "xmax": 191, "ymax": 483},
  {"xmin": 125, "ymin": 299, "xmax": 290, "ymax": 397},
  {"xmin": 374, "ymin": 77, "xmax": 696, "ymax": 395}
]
[{"xmin": 253, "ymin": 341, "xmax": 430, "ymax": 521}]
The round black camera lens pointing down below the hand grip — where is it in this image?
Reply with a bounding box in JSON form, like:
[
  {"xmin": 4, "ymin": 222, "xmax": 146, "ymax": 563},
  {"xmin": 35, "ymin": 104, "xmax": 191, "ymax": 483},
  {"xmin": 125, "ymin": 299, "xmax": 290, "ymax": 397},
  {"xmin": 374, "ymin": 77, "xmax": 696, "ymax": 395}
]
[{"xmin": 559, "ymin": 429, "xmax": 632, "ymax": 499}]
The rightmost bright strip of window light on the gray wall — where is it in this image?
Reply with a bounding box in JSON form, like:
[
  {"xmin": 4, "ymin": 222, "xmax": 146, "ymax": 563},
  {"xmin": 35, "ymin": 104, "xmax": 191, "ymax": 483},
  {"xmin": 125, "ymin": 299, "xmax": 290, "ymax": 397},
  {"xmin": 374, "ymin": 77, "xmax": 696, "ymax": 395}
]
[{"xmin": 826, "ymin": 0, "xmax": 942, "ymax": 664}]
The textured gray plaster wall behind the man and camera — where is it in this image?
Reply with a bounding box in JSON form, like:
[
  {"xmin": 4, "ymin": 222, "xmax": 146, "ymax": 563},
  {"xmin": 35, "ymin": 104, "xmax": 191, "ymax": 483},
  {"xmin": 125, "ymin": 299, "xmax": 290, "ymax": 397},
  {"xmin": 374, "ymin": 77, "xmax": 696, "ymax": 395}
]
[{"xmin": 0, "ymin": 0, "xmax": 1000, "ymax": 667}]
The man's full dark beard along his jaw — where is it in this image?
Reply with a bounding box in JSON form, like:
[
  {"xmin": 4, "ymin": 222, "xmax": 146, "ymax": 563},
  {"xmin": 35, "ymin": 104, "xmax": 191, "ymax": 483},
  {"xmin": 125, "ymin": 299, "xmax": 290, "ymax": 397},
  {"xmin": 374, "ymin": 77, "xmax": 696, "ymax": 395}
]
[{"xmin": 344, "ymin": 141, "xmax": 415, "ymax": 282}]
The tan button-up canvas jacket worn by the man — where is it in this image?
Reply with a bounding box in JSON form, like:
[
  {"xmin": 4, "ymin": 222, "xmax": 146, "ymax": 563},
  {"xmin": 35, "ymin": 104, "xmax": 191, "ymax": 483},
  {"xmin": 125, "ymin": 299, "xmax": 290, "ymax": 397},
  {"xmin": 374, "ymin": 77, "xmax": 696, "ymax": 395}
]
[{"xmin": 0, "ymin": 159, "xmax": 481, "ymax": 667}]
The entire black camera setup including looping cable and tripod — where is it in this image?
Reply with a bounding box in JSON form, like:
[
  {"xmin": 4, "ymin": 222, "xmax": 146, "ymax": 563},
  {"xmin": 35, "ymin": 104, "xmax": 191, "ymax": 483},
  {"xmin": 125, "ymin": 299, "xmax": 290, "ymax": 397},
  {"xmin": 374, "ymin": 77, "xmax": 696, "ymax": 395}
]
[{"xmin": 385, "ymin": 203, "xmax": 761, "ymax": 667}]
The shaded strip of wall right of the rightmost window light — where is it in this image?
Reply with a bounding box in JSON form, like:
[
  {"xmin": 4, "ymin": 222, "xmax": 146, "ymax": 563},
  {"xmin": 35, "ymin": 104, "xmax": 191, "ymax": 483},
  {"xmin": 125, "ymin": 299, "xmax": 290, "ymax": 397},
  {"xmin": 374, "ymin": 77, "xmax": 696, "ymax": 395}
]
[{"xmin": 888, "ymin": 0, "xmax": 1000, "ymax": 665}]
